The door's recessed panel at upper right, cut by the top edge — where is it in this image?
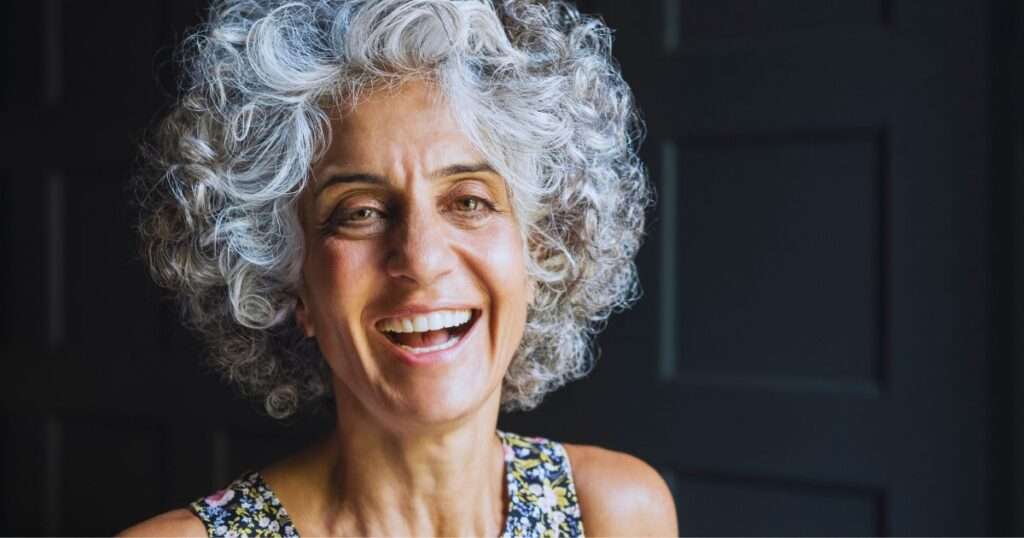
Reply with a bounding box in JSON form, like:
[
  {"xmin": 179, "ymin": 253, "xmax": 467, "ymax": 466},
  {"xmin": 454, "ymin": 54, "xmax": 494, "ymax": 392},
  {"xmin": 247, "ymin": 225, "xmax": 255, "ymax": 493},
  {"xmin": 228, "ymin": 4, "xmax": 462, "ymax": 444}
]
[{"xmin": 665, "ymin": 0, "xmax": 887, "ymax": 42}]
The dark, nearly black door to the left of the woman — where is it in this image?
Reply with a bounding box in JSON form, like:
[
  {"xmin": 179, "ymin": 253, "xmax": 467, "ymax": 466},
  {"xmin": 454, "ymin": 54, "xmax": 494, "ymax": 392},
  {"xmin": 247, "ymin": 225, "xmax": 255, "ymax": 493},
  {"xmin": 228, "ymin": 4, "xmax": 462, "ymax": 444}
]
[{"xmin": 0, "ymin": 0, "xmax": 331, "ymax": 536}]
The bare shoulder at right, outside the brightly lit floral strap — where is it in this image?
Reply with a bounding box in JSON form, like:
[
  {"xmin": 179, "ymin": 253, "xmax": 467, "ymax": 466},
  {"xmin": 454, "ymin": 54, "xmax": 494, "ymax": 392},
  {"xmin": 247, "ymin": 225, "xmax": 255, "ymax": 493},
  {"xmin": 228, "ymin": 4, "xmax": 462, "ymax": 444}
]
[{"xmin": 564, "ymin": 443, "xmax": 679, "ymax": 536}]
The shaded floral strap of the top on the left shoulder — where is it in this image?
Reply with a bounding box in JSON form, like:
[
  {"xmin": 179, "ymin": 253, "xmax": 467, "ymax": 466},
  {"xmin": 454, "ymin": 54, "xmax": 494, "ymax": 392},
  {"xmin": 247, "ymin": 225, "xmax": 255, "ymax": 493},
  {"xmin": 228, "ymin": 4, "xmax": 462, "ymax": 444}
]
[{"xmin": 188, "ymin": 471, "xmax": 299, "ymax": 538}]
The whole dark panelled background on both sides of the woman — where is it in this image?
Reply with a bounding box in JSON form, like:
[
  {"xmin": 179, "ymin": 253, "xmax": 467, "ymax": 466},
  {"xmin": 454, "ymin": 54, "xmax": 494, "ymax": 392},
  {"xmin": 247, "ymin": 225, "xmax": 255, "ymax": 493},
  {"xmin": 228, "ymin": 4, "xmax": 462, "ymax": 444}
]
[{"xmin": 0, "ymin": 0, "xmax": 1024, "ymax": 535}]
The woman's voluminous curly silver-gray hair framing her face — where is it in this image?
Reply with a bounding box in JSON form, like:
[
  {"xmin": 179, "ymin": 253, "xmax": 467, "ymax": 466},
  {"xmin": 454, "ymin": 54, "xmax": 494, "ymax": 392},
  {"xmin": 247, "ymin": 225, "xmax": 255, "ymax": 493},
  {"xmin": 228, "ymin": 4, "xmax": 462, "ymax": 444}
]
[{"xmin": 137, "ymin": 0, "xmax": 650, "ymax": 418}]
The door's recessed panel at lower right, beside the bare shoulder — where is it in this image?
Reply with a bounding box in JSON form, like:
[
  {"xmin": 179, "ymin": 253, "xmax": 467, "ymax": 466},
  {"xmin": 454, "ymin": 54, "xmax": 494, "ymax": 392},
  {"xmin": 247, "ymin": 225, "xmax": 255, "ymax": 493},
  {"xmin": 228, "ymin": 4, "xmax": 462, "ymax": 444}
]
[{"xmin": 673, "ymin": 475, "xmax": 883, "ymax": 536}]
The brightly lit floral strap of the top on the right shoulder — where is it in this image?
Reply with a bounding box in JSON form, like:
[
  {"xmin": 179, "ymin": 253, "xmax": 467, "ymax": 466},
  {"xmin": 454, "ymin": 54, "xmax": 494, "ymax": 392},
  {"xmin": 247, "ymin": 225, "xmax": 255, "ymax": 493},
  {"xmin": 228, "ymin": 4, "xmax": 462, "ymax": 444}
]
[{"xmin": 499, "ymin": 431, "xmax": 584, "ymax": 537}]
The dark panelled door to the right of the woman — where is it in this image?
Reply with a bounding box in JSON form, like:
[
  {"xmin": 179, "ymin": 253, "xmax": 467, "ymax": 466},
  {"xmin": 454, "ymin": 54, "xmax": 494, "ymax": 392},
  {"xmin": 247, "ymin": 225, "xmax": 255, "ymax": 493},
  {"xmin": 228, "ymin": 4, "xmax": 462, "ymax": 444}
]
[{"xmin": 509, "ymin": 0, "xmax": 993, "ymax": 536}]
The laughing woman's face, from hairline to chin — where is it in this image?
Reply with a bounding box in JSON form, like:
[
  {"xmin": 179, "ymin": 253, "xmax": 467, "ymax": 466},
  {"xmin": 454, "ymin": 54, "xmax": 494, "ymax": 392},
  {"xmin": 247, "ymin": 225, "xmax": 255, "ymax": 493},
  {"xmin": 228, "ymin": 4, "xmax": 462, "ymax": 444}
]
[{"xmin": 296, "ymin": 82, "xmax": 532, "ymax": 424}]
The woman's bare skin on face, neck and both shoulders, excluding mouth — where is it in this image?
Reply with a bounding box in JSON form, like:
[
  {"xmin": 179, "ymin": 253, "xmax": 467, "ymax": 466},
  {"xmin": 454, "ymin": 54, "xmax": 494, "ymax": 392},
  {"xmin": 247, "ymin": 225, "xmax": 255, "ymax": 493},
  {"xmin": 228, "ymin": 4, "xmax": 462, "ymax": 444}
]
[{"xmin": 116, "ymin": 82, "xmax": 677, "ymax": 536}]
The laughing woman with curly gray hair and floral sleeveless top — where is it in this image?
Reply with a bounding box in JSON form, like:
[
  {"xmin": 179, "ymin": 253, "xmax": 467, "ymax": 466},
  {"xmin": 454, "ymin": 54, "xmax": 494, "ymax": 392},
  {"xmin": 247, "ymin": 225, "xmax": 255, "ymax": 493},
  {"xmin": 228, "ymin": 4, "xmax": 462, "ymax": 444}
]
[{"xmin": 123, "ymin": 0, "xmax": 676, "ymax": 536}]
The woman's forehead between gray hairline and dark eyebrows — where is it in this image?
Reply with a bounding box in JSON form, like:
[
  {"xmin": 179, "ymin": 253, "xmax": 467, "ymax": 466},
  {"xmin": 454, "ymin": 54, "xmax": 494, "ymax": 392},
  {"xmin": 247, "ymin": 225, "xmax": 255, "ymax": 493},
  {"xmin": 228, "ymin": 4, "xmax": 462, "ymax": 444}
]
[{"xmin": 316, "ymin": 81, "xmax": 482, "ymax": 172}]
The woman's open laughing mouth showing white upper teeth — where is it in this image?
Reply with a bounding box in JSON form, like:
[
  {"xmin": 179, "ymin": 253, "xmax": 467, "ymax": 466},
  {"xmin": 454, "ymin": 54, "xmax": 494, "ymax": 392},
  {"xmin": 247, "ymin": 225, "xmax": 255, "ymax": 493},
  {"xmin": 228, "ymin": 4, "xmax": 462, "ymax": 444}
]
[{"xmin": 377, "ymin": 309, "xmax": 480, "ymax": 354}]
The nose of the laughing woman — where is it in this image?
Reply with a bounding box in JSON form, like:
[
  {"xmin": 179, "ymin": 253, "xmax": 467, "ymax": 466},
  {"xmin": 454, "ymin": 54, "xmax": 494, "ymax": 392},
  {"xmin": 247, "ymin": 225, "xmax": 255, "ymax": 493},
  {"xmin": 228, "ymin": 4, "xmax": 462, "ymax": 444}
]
[{"xmin": 387, "ymin": 200, "xmax": 456, "ymax": 286}]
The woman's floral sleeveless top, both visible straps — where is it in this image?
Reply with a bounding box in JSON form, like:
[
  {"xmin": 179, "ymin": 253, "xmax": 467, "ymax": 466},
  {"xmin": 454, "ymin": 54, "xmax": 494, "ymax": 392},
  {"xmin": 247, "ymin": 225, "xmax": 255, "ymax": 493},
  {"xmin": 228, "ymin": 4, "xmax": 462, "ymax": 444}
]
[{"xmin": 189, "ymin": 430, "xmax": 584, "ymax": 538}]
